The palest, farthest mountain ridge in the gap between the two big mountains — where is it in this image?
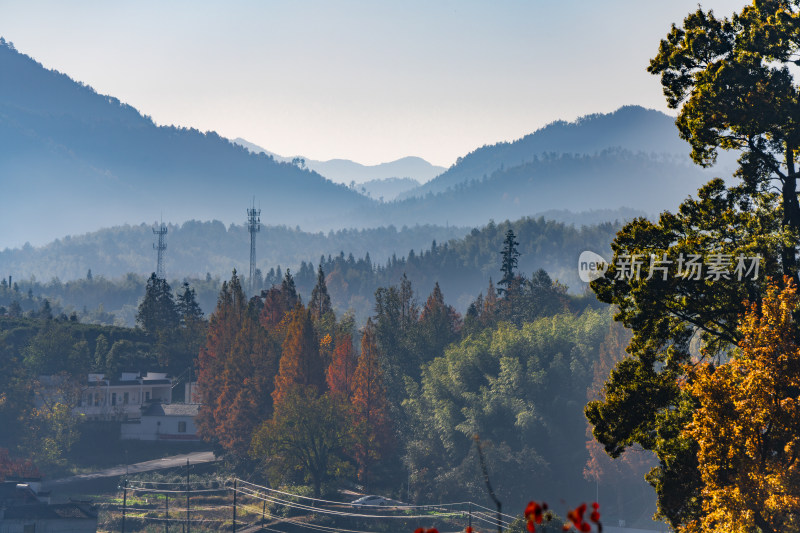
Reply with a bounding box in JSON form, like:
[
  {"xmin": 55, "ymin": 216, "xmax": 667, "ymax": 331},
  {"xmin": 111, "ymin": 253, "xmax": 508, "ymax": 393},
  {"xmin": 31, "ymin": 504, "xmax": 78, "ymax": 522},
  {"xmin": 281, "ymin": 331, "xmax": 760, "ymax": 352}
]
[{"xmin": 233, "ymin": 137, "xmax": 447, "ymax": 185}]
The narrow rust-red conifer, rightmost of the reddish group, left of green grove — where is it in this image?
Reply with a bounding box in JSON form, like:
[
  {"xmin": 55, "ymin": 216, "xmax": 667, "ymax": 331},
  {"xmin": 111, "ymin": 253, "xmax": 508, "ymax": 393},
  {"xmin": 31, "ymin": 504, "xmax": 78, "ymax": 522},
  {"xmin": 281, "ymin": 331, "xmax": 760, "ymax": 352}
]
[{"xmin": 352, "ymin": 319, "xmax": 392, "ymax": 485}]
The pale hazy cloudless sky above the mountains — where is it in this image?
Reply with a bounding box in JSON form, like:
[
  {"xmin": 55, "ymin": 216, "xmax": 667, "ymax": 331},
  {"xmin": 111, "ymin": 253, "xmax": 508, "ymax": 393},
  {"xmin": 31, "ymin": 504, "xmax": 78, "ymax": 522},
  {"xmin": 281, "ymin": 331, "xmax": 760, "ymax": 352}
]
[{"xmin": 0, "ymin": 0, "xmax": 746, "ymax": 166}]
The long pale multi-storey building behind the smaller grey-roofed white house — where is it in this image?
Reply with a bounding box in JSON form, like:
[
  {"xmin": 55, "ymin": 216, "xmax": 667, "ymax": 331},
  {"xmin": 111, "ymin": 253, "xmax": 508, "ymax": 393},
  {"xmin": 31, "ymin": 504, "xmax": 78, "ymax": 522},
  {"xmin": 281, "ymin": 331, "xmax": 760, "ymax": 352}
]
[{"xmin": 79, "ymin": 372, "xmax": 172, "ymax": 420}]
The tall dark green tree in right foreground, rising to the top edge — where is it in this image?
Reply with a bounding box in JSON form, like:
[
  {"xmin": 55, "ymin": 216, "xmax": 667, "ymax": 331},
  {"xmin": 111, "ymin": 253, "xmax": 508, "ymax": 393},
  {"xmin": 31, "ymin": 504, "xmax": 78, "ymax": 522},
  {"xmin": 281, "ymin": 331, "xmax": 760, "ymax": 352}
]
[{"xmin": 586, "ymin": 0, "xmax": 800, "ymax": 531}]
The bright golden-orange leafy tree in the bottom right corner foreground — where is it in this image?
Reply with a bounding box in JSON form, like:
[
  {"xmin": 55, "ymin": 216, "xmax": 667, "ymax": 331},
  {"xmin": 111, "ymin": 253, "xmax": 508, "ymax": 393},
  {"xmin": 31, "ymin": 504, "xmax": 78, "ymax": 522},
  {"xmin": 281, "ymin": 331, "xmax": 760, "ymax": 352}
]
[{"xmin": 686, "ymin": 278, "xmax": 800, "ymax": 533}]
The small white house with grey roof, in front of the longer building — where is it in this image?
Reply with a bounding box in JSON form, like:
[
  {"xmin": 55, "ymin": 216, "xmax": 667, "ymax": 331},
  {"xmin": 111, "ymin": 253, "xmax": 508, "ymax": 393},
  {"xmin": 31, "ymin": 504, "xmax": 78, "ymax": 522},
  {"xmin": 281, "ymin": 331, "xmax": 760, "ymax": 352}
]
[{"xmin": 120, "ymin": 403, "xmax": 200, "ymax": 442}]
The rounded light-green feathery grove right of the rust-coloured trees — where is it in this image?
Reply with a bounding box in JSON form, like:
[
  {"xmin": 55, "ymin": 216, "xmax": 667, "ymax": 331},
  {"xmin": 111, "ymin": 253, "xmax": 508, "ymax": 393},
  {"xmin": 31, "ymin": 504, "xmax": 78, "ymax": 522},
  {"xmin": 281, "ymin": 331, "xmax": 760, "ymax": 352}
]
[{"xmin": 403, "ymin": 310, "xmax": 611, "ymax": 508}]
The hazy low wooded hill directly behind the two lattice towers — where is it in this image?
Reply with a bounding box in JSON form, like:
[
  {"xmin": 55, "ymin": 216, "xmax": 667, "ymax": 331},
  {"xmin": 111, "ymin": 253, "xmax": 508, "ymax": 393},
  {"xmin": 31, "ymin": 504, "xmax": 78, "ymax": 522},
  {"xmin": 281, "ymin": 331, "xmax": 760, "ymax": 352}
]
[{"xmin": 0, "ymin": 219, "xmax": 469, "ymax": 281}]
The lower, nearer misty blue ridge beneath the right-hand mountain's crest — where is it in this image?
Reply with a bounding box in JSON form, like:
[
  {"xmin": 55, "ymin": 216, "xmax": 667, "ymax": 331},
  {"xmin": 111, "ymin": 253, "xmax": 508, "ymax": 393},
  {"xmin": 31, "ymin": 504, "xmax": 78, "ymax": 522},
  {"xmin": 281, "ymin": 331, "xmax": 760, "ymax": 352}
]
[{"xmin": 382, "ymin": 149, "xmax": 709, "ymax": 225}]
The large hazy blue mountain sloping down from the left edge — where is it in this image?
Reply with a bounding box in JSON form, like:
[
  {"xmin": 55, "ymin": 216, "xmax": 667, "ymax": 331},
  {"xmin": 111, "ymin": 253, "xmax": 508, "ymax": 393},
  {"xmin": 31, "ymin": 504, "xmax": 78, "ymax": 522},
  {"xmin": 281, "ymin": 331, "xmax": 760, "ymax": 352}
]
[{"xmin": 0, "ymin": 39, "xmax": 375, "ymax": 248}]
